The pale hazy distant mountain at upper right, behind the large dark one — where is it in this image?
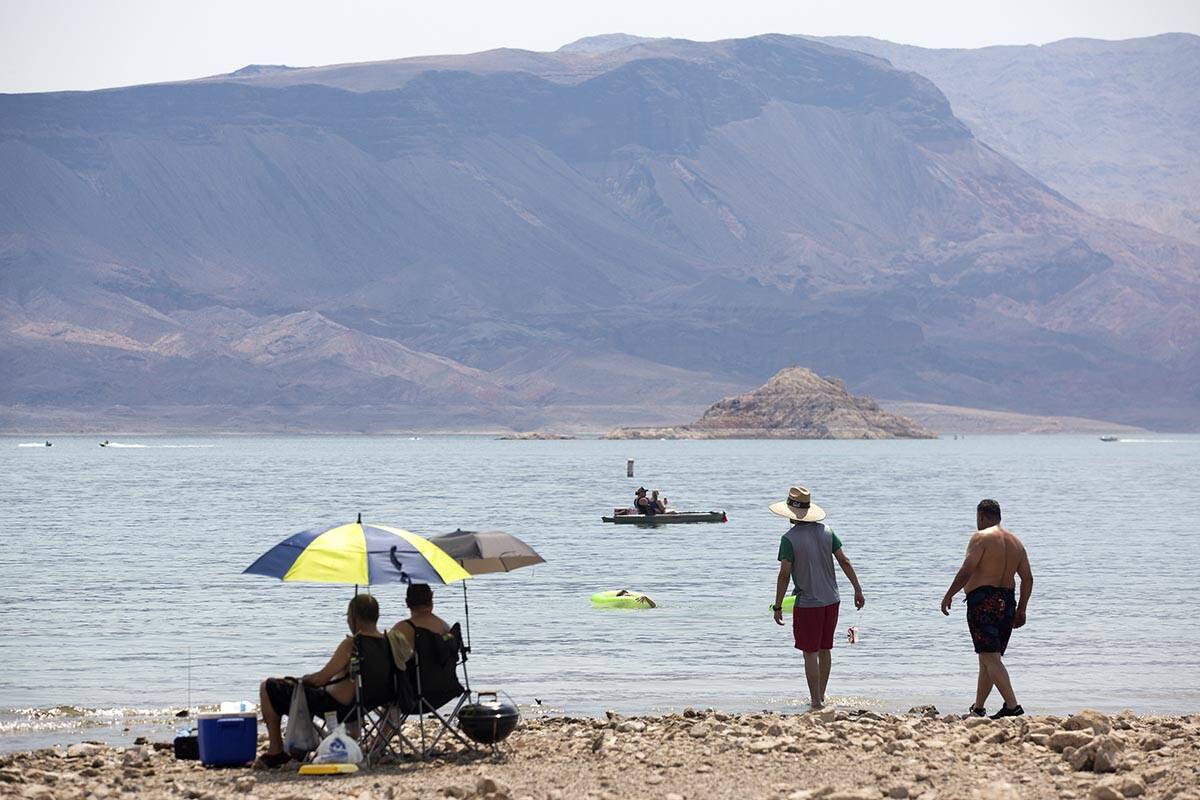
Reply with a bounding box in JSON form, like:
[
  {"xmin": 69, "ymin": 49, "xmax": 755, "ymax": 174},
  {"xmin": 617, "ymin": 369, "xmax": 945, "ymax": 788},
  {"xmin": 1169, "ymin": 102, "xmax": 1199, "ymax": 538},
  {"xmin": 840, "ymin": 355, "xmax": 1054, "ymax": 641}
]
[{"xmin": 822, "ymin": 34, "xmax": 1200, "ymax": 243}]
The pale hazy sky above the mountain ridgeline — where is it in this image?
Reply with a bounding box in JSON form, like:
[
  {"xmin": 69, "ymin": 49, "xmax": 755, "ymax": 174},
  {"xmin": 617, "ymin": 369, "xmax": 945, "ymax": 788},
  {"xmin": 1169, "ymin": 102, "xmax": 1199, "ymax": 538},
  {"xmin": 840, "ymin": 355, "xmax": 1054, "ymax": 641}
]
[{"xmin": 0, "ymin": 0, "xmax": 1200, "ymax": 92}]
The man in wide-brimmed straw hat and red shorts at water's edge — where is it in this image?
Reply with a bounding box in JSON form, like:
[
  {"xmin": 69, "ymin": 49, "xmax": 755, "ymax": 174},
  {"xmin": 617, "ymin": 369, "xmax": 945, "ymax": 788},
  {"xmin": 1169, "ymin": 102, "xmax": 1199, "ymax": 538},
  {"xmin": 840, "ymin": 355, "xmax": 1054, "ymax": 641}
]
[{"xmin": 770, "ymin": 486, "xmax": 866, "ymax": 709}]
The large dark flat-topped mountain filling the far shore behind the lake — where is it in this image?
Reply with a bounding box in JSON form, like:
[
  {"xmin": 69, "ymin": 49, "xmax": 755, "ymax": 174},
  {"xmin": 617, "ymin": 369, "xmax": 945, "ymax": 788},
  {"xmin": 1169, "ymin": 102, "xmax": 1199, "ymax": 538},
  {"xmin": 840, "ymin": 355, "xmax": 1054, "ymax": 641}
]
[{"xmin": 0, "ymin": 35, "xmax": 1200, "ymax": 431}]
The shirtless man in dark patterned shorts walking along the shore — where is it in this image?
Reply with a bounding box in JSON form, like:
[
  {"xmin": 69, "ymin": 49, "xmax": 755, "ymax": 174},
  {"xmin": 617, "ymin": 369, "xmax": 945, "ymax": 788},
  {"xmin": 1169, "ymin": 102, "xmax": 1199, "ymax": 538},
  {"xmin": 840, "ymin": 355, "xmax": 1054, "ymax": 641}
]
[{"xmin": 942, "ymin": 500, "xmax": 1033, "ymax": 720}]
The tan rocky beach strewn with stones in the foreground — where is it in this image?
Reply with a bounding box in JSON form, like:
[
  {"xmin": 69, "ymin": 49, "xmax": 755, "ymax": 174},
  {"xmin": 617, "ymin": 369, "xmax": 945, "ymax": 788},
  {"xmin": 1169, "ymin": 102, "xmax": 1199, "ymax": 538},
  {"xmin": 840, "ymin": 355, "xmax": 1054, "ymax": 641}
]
[{"xmin": 0, "ymin": 706, "xmax": 1200, "ymax": 800}]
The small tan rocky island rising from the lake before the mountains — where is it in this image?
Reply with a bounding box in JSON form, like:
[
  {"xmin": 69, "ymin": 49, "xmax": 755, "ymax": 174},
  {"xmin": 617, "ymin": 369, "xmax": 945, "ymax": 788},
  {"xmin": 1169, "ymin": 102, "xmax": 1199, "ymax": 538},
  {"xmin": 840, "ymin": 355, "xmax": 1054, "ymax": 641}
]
[{"xmin": 606, "ymin": 367, "xmax": 937, "ymax": 439}]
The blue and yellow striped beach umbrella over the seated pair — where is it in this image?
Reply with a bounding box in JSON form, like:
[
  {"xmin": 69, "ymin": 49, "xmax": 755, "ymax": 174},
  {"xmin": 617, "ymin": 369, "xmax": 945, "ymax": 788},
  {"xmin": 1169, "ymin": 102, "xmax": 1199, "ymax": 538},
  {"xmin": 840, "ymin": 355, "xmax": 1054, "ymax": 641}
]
[{"xmin": 242, "ymin": 515, "xmax": 470, "ymax": 587}]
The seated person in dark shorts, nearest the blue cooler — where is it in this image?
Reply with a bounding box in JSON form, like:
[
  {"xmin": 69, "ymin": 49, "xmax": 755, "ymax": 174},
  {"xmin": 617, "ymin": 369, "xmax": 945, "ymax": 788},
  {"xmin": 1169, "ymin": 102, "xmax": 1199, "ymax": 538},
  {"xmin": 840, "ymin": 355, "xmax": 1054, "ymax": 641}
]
[{"xmin": 258, "ymin": 595, "xmax": 390, "ymax": 766}]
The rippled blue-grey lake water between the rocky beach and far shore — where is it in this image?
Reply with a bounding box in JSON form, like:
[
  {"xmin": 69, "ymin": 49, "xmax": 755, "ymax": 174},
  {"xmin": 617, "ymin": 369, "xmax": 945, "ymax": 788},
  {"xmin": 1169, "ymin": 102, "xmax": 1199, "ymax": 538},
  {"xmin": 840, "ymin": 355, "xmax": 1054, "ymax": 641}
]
[{"xmin": 0, "ymin": 435, "xmax": 1200, "ymax": 750}]
